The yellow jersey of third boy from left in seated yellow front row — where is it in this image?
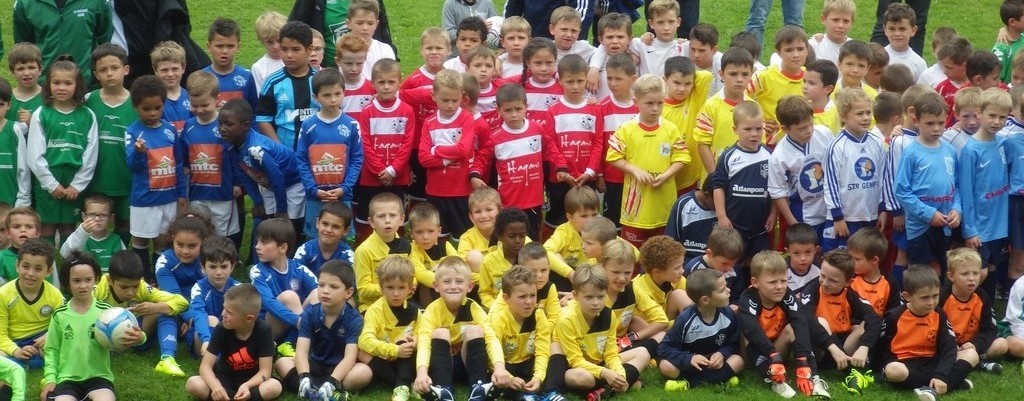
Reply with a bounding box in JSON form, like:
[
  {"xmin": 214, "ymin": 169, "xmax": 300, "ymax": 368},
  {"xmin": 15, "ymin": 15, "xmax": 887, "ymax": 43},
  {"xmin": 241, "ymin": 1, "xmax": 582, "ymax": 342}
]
[{"xmin": 487, "ymin": 308, "xmax": 552, "ymax": 382}]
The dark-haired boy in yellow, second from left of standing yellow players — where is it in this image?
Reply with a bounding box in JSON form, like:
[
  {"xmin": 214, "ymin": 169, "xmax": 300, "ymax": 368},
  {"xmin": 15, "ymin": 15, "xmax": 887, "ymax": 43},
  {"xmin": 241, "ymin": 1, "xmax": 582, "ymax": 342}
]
[{"xmin": 662, "ymin": 56, "xmax": 714, "ymax": 193}]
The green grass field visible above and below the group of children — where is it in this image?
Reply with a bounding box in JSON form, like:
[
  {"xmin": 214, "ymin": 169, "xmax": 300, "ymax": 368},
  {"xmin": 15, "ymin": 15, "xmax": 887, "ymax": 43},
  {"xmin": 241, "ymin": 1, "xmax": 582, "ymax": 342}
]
[{"xmin": 6, "ymin": 0, "xmax": 1024, "ymax": 400}]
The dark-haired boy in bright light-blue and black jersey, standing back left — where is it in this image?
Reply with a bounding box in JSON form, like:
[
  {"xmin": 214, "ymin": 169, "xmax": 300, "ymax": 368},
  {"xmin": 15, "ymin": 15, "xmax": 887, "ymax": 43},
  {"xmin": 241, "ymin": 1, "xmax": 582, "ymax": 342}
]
[{"xmin": 256, "ymin": 20, "xmax": 319, "ymax": 150}]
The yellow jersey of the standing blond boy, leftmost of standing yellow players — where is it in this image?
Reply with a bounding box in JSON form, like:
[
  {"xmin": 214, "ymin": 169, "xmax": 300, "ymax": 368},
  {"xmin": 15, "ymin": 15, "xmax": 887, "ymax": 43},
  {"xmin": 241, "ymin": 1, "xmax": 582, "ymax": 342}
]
[{"xmin": 607, "ymin": 118, "xmax": 690, "ymax": 229}]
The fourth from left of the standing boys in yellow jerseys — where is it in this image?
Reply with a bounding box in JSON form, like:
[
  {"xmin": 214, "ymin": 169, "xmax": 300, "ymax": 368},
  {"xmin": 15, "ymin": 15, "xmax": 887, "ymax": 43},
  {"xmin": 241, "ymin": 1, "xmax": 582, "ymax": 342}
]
[{"xmin": 746, "ymin": 26, "xmax": 807, "ymax": 145}]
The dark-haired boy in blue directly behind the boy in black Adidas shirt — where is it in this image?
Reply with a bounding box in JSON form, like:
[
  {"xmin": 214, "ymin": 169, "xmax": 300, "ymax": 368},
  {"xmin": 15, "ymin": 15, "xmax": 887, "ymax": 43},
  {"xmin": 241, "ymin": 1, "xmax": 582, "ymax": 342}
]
[{"xmin": 183, "ymin": 236, "xmax": 240, "ymax": 355}]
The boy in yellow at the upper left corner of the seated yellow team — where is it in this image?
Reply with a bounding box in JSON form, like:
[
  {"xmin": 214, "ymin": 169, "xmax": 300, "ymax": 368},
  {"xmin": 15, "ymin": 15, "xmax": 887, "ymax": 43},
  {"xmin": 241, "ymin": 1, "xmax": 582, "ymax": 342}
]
[{"xmin": 354, "ymin": 192, "xmax": 416, "ymax": 313}]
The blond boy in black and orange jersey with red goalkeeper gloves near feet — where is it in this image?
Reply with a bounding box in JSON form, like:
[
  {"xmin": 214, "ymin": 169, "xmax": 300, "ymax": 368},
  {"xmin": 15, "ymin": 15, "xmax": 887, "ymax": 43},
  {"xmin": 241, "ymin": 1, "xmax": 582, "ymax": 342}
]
[{"xmin": 737, "ymin": 251, "xmax": 831, "ymax": 399}]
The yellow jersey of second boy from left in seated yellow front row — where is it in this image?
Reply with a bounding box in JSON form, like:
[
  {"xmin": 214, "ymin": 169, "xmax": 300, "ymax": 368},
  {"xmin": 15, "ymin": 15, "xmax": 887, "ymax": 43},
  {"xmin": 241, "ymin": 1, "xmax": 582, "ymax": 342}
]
[{"xmin": 416, "ymin": 298, "xmax": 505, "ymax": 368}]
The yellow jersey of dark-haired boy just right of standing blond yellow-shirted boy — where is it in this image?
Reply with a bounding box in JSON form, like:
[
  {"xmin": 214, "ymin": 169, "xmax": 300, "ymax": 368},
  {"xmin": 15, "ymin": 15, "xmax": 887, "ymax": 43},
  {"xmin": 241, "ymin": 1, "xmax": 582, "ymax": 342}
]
[{"xmin": 662, "ymin": 71, "xmax": 714, "ymax": 189}]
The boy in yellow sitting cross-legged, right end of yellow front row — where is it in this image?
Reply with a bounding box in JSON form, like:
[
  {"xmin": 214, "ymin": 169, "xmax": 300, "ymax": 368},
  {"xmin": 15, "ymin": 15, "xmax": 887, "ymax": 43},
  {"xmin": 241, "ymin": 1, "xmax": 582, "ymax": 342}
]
[{"xmin": 549, "ymin": 265, "xmax": 650, "ymax": 400}]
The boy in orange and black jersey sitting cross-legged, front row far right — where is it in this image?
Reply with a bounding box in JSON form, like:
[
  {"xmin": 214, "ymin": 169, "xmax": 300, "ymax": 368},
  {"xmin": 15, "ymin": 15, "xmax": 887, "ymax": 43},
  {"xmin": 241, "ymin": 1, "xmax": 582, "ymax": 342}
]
[{"xmin": 878, "ymin": 266, "xmax": 978, "ymax": 401}]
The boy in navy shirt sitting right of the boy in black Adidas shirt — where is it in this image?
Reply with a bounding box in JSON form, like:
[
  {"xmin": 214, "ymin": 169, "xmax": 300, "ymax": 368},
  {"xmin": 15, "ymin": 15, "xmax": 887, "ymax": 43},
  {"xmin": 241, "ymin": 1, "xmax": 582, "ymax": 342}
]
[{"xmin": 274, "ymin": 260, "xmax": 373, "ymax": 400}]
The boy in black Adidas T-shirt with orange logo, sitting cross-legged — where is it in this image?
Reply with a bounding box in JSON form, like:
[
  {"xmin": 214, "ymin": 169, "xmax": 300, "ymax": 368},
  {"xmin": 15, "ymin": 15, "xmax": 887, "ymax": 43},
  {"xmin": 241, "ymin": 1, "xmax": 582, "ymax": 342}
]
[{"xmin": 185, "ymin": 283, "xmax": 281, "ymax": 400}]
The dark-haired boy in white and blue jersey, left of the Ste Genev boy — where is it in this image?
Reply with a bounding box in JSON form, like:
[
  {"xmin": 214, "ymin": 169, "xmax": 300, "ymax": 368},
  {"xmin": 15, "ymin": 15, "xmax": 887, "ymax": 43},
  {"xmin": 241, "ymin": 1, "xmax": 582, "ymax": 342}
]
[{"xmin": 768, "ymin": 96, "xmax": 833, "ymax": 236}]
